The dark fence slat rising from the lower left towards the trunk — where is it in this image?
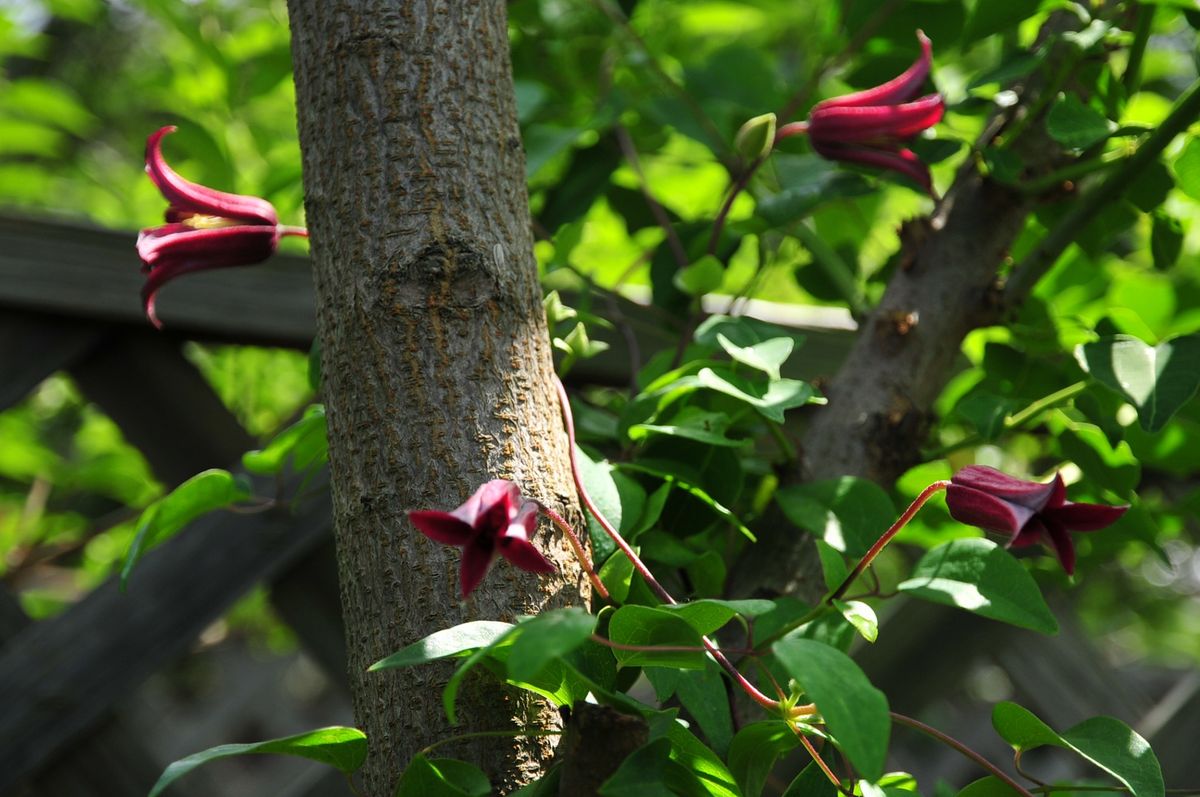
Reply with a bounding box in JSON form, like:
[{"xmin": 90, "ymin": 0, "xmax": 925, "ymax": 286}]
[{"xmin": 0, "ymin": 485, "xmax": 330, "ymax": 793}]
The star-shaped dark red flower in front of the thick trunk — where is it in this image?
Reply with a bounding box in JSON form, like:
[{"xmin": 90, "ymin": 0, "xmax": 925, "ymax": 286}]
[{"xmin": 408, "ymin": 479, "xmax": 557, "ymax": 598}]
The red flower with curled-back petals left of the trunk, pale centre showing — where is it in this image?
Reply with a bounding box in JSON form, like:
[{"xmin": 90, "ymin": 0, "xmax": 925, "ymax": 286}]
[{"xmin": 138, "ymin": 126, "xmax": 308, "ymax": 328}]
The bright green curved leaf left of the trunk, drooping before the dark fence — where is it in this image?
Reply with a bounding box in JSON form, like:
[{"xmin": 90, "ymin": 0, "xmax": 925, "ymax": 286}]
[{"xmin": 121, "ymin": 469, "xmax": 251, "ymax": 589}]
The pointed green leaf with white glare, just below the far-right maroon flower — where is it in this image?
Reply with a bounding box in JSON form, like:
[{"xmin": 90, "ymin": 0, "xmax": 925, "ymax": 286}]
[{"xmin": 898, "ymin": 538, "xmax": 1058, "ymax": 634}]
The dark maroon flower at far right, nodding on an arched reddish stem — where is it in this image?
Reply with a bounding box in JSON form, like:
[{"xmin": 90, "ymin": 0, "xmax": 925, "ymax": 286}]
[{"xmin": 946, "ymin": 465, "xmax": 1129, "ymax": 575}]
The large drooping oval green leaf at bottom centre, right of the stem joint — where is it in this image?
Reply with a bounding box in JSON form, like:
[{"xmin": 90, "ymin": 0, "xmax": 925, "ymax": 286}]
[{"xmin": 773, "ymin": 636, "xmax": 892, "ymax": 780}]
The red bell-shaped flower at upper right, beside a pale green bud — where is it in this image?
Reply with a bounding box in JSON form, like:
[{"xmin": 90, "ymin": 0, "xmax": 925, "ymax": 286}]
[{"xmin": 776, "ymin": 30, "xmax": 946, "ymax": 197}]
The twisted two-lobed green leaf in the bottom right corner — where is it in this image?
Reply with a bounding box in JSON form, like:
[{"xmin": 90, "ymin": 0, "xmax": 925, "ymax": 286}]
[{"xmin": 991, "ymin": 702, "xmax": 1165, "ymax": 797}]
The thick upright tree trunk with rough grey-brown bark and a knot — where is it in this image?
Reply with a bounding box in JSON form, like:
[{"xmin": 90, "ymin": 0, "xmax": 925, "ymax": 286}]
[{"xmin": 289, "ymin": 0, "xmax": 587, "ymax": 797}]
